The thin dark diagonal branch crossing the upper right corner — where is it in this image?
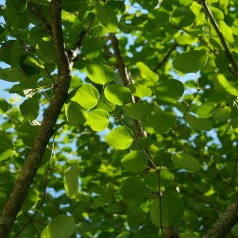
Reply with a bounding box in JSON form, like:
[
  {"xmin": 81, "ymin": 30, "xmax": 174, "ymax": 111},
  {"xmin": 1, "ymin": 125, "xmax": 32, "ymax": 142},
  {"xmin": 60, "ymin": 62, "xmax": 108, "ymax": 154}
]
[{"xmin": 200, "ymin": 0, "xmax": 238, "ymax": 79}]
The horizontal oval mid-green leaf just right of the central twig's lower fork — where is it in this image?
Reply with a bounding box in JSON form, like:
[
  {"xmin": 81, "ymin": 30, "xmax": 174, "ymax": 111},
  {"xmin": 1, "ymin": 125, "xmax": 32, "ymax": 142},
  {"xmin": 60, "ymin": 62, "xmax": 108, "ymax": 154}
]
[{"xmin": 171, "ymin": 153, "xmax": 201, "ymax": 172}]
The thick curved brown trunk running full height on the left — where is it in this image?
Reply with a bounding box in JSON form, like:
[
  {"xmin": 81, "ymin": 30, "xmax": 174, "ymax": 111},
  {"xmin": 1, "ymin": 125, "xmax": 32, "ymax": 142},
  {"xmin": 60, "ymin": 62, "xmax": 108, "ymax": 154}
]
[{"xmin": 0, "ymin": 0, "xmax": 71, "ymax": 238}]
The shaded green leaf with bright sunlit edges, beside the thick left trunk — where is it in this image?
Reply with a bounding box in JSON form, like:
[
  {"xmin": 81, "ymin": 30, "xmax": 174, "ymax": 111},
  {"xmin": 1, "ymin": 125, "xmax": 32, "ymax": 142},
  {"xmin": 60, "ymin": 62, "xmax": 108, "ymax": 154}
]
[{"xmin": 65, "ymin": 101, "xmax": 88, "ymax": 127}]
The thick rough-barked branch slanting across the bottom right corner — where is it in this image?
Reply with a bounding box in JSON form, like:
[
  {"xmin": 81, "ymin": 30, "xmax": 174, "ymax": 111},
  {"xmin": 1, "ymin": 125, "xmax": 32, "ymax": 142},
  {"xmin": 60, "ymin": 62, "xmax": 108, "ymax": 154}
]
[{"xmin": 203, "ymin": 199, "xmax": 238, "ymax": 238}]
